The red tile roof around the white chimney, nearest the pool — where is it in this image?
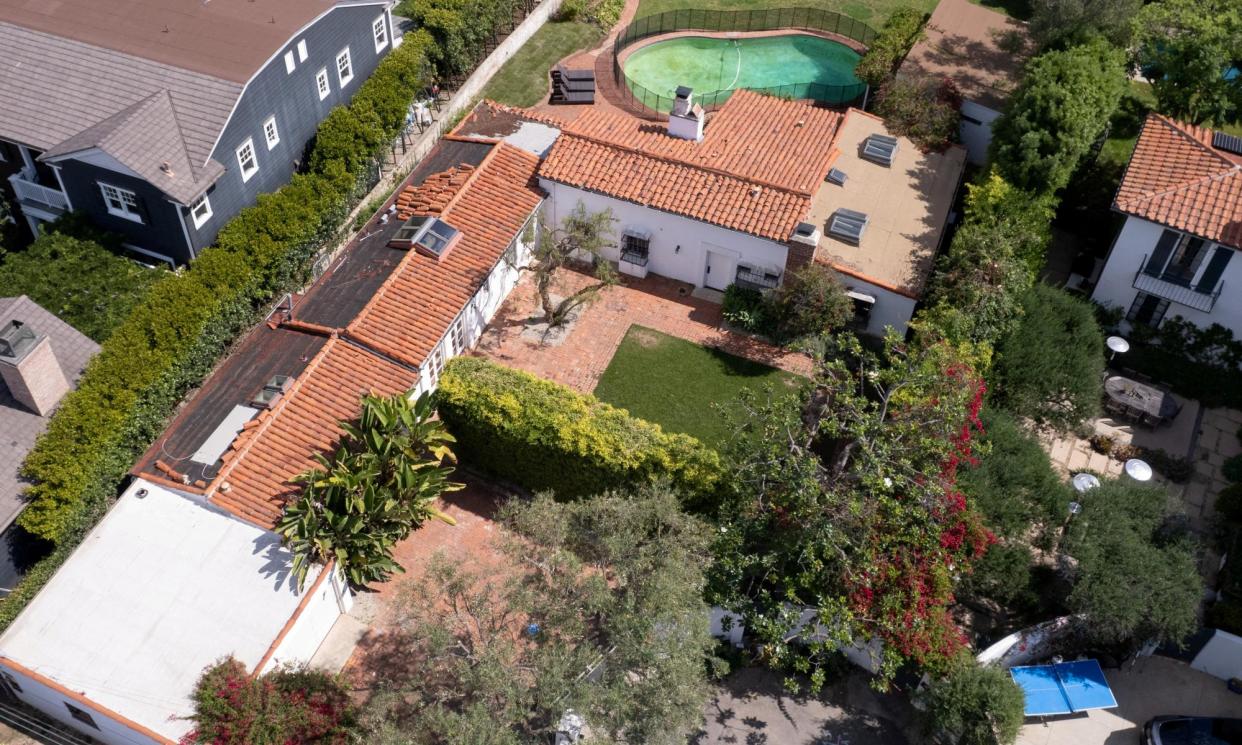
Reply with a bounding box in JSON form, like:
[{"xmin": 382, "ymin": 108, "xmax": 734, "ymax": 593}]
[{"xmin": 539, "ymin": 91, "xmax": 842, "ymax": 241}]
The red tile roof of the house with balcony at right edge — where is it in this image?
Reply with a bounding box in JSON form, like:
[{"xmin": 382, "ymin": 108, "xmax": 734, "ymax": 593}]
[{"xmin": 1113, "ymin": 113, "xmax": 1242, "ymax": 248}]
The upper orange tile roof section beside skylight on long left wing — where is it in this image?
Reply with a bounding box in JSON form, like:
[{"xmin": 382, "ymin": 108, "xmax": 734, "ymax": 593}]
[{"xmin": 345, "ymin": 143, "xmax": 543, "ymax": 365}]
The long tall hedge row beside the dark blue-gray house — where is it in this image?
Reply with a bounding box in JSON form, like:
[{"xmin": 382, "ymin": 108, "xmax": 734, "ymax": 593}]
[{"xmin": 0, "ymin": 34, "xmax": 428, "ymax": 626}]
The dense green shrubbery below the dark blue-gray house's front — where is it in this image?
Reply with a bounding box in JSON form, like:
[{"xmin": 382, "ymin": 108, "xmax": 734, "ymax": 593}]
[{"xmin": 0, "ymin": 228, "xmax": 163, "ymax": 341}]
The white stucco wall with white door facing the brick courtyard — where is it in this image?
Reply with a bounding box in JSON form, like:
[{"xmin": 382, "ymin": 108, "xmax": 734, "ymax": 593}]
[{"xmin": 539, "ymin": 179, "xmax": 789, "ymax": 288}]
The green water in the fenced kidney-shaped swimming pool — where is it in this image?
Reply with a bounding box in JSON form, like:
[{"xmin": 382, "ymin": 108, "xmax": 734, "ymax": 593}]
[{"xmin": 623, "ymin": 34, "xmax": 864, "ymax": 109}]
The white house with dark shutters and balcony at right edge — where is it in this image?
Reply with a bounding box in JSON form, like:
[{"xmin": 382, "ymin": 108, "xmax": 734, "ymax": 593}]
[{"xmin": 1092, "ymin": 113, "xmax": 1242, "ymax": 336}]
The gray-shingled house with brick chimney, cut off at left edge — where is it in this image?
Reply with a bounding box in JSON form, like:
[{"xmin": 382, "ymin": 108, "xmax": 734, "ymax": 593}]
[{"xmin": 0, "ymin": 296, "xmax": 99, "ymax": 530}]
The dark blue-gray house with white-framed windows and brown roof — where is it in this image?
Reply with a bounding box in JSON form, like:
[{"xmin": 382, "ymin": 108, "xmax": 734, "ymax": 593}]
[{"xmin": 0, "ymin": 0, "xmax": 394, "ymax": 263}]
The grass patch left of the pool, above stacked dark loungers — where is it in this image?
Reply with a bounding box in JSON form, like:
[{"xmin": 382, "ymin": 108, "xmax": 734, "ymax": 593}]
[{"xmin": 483, "ymin": 21, "xmax": 604, "ymax": 107}]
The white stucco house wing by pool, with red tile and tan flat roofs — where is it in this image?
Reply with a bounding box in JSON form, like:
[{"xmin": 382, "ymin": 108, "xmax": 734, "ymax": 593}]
[{"xmin": 479, "ymin": 91, "xmax": 965, "ymax": 334}]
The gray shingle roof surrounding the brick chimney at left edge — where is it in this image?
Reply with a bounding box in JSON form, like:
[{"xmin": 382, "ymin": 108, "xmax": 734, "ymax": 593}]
[{"xmin": 0, "ymin": 296, "xmax": 99, "ymax": 529}]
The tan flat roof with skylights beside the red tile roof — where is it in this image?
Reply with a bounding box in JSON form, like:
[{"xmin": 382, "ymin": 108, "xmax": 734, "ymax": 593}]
[{"xmin": 807, "ymin": 109, "xmax": 966, "ymax": 298}]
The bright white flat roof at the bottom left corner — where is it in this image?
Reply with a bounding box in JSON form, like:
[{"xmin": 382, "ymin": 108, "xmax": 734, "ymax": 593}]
[{"xmin": 0, "ymin": 479, "xmax": 319, "ymax": 740}]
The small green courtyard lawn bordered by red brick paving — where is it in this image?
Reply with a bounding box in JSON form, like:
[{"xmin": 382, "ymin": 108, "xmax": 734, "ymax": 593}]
[{"xmin": 595, "ymin": 325, "xmax": 806, "ymax": 448}]
